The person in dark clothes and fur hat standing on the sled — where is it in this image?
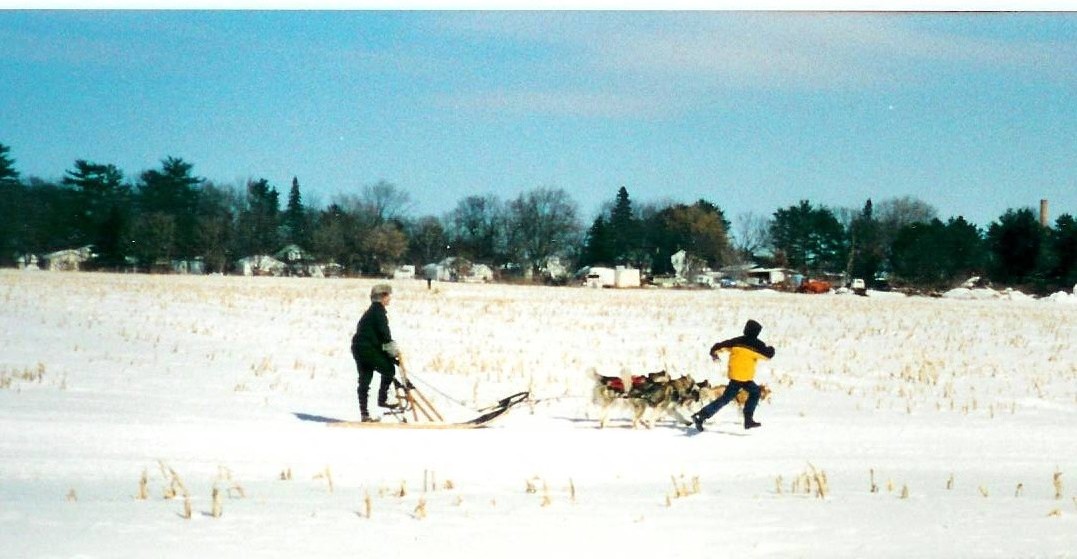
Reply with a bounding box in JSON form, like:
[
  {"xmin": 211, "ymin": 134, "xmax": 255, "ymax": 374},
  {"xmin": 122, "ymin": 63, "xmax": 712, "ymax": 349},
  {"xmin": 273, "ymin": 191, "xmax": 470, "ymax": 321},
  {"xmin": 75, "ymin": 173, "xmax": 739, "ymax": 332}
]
[{"xmin": 351, "ymin": 283, "xmax": 401, "ymax": 421}]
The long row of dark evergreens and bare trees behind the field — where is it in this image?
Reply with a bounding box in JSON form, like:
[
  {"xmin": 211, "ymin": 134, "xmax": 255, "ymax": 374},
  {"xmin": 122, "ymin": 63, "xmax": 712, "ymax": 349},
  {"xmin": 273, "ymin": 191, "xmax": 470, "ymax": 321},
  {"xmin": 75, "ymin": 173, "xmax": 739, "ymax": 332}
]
[{"xmin": 0, "ymin": 144, "xmax": 1077, "ymax": 293}]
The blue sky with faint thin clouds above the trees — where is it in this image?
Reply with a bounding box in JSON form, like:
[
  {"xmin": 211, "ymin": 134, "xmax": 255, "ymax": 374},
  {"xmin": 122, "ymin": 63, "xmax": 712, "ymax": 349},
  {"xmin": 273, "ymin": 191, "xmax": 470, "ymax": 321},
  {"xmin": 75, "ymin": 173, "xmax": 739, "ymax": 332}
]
[{"xmin": 0, "ymin": 10, "xmax": 1077, "ymax": 226}]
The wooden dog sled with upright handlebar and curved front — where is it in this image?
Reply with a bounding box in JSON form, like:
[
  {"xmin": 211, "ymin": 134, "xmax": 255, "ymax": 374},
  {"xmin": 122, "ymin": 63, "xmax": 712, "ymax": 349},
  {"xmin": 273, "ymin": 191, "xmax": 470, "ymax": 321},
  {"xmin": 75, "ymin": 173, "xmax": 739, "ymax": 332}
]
[{"xmin": 326, "ymin": 368, "xmax": 531, "ymax": 429}]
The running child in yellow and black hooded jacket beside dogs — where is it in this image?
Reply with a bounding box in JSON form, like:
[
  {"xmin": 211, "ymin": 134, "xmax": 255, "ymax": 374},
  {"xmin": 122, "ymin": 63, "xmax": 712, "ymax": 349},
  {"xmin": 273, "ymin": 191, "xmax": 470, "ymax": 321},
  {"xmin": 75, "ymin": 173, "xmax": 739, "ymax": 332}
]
[{"xmin": 691, "ymin": 320, "xmax": 774, "ymax": 431}]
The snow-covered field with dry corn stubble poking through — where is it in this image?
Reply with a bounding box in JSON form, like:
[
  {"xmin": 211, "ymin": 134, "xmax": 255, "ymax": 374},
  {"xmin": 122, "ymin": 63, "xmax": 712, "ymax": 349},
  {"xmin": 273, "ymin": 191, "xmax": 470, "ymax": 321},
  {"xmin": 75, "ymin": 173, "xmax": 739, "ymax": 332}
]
[{"xmin": 0, "ymin": 270, "xmax": 1077, "ymax": 558}]
